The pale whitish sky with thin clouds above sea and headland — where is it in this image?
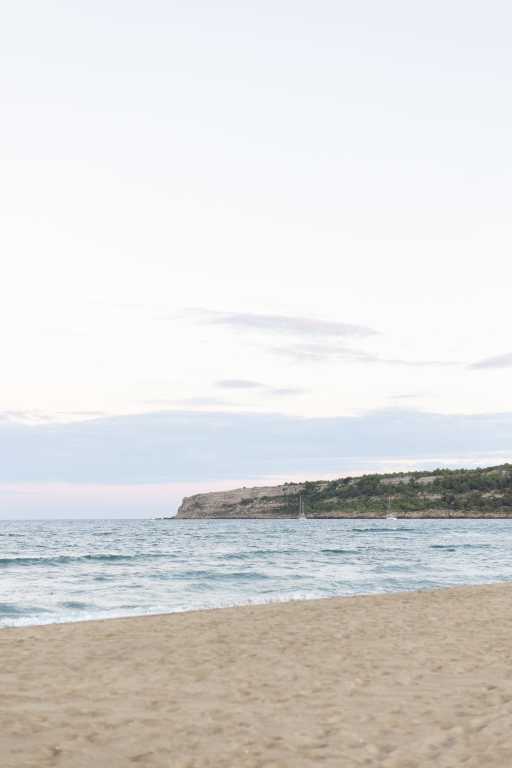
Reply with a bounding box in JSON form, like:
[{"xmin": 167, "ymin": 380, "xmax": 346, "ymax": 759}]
[{"xmin": 0, "ymin": 0, "xmax": 512, "ymax": 518}]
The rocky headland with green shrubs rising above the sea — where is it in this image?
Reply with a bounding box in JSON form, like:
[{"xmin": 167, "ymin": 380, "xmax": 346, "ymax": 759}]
[{"xmin": 177, "ymin": 464, "xmax": 512, "ymax": 519}]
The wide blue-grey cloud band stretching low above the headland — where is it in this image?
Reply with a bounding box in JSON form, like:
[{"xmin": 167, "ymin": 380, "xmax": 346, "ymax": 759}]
[{"xmin": 0, "ymin": 409, "xmax": 512, "ymax": 485}]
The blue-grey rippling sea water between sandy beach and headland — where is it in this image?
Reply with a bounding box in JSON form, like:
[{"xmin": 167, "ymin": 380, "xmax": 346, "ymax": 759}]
[{"xmin": 0, "ymin": 520, "xmax": 512, "ymax": 627}]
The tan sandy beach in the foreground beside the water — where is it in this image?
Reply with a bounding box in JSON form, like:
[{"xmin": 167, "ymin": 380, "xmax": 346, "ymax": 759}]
[{"xmin": 0, "ymin": 585, "xmax": 512, "ymax": 768}]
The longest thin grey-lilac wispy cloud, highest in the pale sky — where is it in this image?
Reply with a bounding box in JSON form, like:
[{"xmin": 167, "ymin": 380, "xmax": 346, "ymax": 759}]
[{"xmin": 192, "ymin": 309, "xmax": 377, "ymax": 338}]
